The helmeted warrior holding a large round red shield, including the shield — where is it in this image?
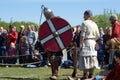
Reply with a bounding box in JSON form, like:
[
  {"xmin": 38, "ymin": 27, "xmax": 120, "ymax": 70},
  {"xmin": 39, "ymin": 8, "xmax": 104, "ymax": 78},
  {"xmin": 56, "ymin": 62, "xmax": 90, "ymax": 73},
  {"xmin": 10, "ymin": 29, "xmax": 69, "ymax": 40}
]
[{"xmin": 39, "ymin": 6, "xmax": 72, "ymax": 80}]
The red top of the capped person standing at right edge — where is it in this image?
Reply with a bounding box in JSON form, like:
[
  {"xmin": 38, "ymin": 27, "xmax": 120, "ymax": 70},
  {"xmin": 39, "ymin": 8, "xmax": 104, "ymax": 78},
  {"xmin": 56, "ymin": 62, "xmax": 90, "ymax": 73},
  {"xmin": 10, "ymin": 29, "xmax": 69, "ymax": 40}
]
[{"xmin": 111, "ymin": 22, "xmax": 120, "ymax": 38}]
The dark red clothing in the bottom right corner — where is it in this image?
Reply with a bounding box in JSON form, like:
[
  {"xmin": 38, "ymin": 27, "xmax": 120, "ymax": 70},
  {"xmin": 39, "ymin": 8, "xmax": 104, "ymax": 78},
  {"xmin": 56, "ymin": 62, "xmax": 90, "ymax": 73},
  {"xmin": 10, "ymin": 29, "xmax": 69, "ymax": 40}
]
[{"xmin": 104, "ymin": 63, "xmax": 120, "ymax": 80}]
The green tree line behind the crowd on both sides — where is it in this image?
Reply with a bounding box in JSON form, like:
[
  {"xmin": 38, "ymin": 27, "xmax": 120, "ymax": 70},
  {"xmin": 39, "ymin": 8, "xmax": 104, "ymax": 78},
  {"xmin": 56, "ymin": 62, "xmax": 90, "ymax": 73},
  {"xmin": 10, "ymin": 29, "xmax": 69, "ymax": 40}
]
[{"xmin": 0, "ymin": 9, "xmax": 120, "ymax": 31}]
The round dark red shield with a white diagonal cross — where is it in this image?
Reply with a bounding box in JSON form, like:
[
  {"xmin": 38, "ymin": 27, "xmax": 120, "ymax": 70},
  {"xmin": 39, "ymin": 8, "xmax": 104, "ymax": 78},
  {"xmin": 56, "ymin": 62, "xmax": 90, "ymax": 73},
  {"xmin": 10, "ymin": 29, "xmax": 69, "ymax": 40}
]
[{"xmin": 39, "ymin": 17, "xmax": 73, "ymax": 52}]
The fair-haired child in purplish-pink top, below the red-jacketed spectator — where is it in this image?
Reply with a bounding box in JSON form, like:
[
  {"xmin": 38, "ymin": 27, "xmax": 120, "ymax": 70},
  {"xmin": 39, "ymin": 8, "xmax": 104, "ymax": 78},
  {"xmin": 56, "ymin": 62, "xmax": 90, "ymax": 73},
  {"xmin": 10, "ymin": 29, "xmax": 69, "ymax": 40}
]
[{"xmin": 6, "ymin": 42, "xmax": 17, "ymax": 64}]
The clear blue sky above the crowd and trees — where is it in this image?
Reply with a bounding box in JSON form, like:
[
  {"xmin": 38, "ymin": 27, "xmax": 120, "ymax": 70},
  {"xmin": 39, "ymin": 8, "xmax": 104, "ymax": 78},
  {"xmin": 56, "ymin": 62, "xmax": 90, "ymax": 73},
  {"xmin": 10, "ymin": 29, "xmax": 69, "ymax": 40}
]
[{"xmin": 0, "ymin": 0, "xmax": 120, "ymax": 26}]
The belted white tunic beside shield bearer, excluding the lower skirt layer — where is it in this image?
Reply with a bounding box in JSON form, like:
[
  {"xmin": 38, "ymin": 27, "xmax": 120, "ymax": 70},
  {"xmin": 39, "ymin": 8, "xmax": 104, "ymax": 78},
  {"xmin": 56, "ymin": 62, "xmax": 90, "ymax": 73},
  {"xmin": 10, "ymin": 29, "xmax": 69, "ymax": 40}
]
[{"xmin": 80, "ymin": 20, "xmax": 99, "ymax": 56}]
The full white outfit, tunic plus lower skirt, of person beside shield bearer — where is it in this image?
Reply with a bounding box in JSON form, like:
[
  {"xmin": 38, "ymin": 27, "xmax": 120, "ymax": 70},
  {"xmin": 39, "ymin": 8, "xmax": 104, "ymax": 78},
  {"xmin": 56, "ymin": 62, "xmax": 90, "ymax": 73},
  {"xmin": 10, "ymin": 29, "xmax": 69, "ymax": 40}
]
[{"xmin": 77, "ymin": 20, "xmax": 99, "ymax": 69}]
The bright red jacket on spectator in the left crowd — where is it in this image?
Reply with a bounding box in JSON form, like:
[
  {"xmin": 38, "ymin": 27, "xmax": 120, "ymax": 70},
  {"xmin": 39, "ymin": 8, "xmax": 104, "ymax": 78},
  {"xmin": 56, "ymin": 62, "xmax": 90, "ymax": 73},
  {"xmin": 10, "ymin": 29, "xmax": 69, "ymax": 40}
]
[{"xmin": 5, "ymin": 31, "xmax": 18, "ymax": 47}]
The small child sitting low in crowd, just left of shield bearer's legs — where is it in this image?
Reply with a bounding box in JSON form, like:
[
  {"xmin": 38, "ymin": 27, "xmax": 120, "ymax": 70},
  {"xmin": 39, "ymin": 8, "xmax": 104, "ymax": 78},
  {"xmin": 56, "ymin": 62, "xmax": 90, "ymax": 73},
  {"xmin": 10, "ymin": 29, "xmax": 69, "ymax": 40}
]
[{"xmin": 32, "ymin": 49, "xmax": 43, "ymax": 67}]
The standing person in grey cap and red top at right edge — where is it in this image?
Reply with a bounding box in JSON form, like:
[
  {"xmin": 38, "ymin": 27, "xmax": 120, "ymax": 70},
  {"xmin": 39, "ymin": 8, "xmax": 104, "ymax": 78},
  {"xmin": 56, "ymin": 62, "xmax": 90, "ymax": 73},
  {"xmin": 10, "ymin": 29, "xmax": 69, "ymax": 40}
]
[{"xmin": 108, "ymin": 15, "xmax": 120, "ymax": 69}]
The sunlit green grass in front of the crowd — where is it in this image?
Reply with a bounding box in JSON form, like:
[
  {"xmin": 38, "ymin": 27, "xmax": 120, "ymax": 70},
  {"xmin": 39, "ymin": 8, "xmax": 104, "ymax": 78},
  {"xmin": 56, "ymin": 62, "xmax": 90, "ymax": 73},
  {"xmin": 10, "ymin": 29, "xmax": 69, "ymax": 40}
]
[{"xmin": 0, "ymin": 67, "xmax": 100, "ymax": 80}]
